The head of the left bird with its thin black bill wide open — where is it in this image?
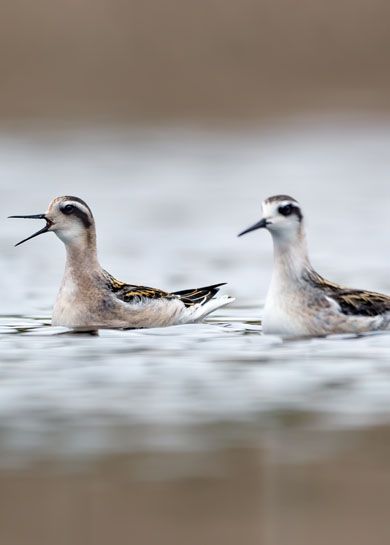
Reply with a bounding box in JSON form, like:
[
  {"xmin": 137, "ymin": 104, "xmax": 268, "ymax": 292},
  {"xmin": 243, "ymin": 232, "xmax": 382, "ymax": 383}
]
[{"xmin": 10, "ymin": 196, "xmax": 95, "ymax": 246}]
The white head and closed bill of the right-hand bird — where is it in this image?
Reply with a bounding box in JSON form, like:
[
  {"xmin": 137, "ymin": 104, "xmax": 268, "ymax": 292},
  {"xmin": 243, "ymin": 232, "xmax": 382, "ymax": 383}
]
[{"xmin": 239, "ymin": 195, "xmax": 303, "ymax": 243}]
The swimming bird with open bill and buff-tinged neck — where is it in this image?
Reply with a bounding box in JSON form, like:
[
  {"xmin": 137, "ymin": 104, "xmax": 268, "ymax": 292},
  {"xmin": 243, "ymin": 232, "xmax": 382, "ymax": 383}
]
[{"xmin": 10, "ymin": 196, "xmax": 234, "ymax": 328}]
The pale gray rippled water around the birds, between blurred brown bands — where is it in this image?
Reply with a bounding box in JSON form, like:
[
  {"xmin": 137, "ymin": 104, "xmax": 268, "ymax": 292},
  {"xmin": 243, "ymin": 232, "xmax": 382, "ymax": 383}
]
[{"xmin": 0, "ymin": 118, "xmax": 390, "ymax": 467}]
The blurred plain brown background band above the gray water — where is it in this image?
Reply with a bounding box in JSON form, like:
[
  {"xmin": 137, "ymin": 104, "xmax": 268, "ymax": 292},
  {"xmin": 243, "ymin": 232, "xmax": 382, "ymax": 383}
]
[{"xmin": 0, "ymin": 0, "xmax": 390, "ymax": 122}]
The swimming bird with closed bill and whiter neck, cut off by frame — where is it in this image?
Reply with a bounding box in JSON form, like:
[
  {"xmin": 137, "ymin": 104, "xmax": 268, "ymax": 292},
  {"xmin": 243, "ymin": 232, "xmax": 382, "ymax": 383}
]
[{"xmin": 239, "ymin": 191, "xmax": 390, "ymax": 336}]
